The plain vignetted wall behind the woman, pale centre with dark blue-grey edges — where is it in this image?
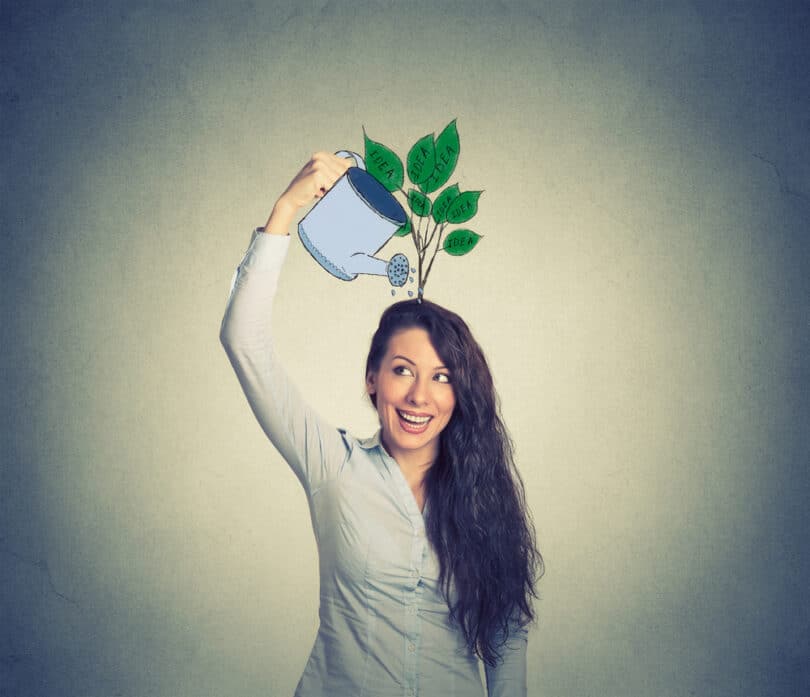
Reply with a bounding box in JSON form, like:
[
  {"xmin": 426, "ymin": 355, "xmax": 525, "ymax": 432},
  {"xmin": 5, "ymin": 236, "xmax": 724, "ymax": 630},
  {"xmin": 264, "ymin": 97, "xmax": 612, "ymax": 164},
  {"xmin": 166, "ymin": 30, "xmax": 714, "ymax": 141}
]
[{"xmin": 0, "ymin": 0, "xmax": 810, "ymax": 697}]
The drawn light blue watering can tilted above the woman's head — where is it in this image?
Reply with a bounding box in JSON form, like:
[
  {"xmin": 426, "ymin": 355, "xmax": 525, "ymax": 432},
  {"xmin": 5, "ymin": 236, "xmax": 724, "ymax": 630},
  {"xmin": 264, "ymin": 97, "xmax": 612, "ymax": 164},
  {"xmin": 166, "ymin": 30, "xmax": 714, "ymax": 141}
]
[{"xmin": 298, "ymin": 150, "xmax": 410, "ymax": 286}]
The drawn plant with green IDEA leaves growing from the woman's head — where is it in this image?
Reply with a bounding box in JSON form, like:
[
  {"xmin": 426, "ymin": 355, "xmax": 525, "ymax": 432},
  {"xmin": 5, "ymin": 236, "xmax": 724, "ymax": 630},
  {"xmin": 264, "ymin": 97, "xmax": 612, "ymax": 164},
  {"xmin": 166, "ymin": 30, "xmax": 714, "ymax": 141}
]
[{"xmin": 363, "ymin": 119, "xmax": 483, "ymax": 296}]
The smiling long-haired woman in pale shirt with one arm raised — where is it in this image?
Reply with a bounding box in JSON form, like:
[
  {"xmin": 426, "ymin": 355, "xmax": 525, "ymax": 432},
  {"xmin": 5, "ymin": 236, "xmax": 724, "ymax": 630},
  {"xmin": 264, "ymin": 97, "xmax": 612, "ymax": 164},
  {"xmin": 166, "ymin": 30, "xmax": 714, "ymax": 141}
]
[{"xmin": 221, "ymin": 153, "xmax": 542, "ymax": 697}]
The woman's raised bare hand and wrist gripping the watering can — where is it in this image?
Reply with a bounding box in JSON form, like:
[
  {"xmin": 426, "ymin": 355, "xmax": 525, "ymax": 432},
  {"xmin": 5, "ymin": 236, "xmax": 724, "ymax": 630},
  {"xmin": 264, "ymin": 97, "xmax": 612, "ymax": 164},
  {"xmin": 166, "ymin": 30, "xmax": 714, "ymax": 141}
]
[{"xmin": 264, "ymin": 152, "xmax": 354, "ymax": 235}]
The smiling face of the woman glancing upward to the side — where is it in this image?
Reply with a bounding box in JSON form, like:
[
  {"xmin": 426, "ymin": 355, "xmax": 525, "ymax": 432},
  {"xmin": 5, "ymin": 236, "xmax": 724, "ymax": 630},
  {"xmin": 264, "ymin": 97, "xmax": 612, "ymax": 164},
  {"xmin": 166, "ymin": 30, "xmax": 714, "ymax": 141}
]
[{"xmin": 366, "ymin": 327, "xmax": 456, "ymax": 465}]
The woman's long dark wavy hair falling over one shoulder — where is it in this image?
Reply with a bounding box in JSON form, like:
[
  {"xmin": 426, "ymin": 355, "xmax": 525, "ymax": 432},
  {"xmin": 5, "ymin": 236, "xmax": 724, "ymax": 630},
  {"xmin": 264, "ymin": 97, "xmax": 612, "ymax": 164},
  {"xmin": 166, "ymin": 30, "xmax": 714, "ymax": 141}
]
[{"xmin": 366, "ymin": 300, "xmax": 543, "ymax": 665}]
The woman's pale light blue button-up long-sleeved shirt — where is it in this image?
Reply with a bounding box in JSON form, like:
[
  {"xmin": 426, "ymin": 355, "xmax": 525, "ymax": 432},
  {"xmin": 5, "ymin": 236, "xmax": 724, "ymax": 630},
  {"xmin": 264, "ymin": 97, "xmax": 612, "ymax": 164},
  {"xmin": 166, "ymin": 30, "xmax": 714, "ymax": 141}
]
[{"xmin": 220, "ymin": 230, "xmax": 526, "ymax": 697}]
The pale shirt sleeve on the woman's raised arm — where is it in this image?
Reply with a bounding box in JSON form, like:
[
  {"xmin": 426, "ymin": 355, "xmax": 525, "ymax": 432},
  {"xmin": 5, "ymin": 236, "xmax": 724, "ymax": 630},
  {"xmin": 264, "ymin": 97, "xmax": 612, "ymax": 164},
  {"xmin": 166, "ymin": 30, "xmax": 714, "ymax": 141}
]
[{"xmin": 220, "ymin": 228, "xmax": 347, "ymax": 495}]
